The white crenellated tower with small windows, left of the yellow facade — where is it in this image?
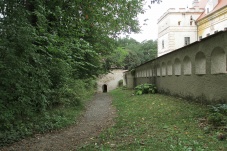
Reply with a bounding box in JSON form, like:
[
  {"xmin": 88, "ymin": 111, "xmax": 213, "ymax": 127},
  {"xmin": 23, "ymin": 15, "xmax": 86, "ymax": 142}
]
[{"xmin": 158, "ymin": 7, "xmax": 204, "ymax": 56}]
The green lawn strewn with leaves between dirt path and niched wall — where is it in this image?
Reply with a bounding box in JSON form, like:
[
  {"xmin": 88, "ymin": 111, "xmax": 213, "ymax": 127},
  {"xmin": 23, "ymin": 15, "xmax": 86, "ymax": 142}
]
[{"xmin": 79, "ymin": 89, "xmax": 227, "ymax": 151}]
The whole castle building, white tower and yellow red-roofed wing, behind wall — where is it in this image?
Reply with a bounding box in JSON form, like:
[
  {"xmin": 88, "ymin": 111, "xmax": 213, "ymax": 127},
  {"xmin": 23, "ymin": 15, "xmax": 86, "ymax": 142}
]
[{"xmin": 158, "ymin": 0, "xmax": 227, "ymax": 56}]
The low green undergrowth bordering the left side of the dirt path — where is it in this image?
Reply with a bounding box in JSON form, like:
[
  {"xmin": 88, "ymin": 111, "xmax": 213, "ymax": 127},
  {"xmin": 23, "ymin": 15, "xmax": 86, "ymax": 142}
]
[{"xmin": 0, "ymin": 79, "xmax": 95, "ymax": 147}]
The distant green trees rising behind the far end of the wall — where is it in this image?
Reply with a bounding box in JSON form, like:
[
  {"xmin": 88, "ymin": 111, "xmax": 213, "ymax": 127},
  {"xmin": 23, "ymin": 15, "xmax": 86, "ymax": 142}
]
[{"xmin": 107, "ymin": 38, "xmax": 157, "ymax": 70}]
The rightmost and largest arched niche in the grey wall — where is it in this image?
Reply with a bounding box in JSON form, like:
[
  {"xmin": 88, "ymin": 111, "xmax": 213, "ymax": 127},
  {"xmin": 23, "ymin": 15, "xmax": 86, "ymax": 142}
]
[{"xmin": 211, "ymin": 47, "xmax": 226, "ymax": 74}]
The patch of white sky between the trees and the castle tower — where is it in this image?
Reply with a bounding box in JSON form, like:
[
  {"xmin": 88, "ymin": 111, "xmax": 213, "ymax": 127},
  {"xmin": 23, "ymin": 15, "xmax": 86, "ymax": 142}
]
[{"xmin": 129, "ymin": 0, "xmax": 193, "ymax": 42}]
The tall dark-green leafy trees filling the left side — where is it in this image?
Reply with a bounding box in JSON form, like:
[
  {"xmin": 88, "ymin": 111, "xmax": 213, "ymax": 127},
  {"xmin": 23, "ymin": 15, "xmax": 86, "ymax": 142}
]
[{"xmin": 0, "ymin": 0, "xmax": 143, "ymax": 145}]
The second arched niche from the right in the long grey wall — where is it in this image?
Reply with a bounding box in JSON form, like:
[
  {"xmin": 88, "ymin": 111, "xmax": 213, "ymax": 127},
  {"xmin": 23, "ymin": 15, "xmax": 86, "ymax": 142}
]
[{"xmin": 195, "ymin": 51, "xmax": 206, "ymax": 74}]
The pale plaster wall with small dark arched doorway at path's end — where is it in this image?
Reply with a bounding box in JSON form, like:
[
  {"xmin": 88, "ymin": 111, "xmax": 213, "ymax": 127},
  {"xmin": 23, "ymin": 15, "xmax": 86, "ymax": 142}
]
[{"xmin": 97, "ymin": 69, "xmax": 126, "ymax": 92}]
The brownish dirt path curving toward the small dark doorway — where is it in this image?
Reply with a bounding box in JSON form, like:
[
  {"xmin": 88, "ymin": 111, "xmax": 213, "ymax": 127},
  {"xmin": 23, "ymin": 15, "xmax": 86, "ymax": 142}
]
[{"xmin": 1, "ymin": 93, "xmax": 115, "ymax": 151}]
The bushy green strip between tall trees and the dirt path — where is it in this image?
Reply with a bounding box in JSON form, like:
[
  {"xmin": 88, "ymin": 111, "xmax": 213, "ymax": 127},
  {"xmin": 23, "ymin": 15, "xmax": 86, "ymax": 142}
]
[{"xmin": 0, "ymin": 78, "xmax": 96, "ymax": 147}]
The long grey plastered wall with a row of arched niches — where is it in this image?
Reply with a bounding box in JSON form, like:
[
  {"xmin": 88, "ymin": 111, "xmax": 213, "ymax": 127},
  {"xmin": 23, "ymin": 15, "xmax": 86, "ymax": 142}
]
[{"xmin": 126, "ymin": 31, "xmax": 227, "ymax": 102}]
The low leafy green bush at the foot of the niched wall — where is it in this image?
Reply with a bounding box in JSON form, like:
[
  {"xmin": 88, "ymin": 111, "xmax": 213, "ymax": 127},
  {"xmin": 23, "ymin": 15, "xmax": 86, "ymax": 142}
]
[{"xmin": 135, "ymin": 83, "xmax": 157, "ymax": 95}]
